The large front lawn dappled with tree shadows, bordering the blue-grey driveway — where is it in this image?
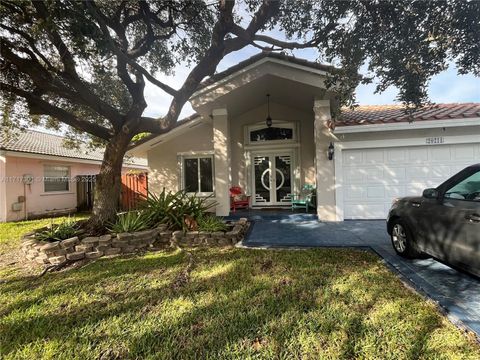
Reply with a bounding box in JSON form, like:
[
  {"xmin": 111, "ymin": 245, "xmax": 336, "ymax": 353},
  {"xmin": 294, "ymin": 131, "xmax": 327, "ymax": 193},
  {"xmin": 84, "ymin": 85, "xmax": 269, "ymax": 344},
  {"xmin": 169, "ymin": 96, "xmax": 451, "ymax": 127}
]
[{"xmin": 0, "ymin": 249, "xmax": 480, "ymax": 359}]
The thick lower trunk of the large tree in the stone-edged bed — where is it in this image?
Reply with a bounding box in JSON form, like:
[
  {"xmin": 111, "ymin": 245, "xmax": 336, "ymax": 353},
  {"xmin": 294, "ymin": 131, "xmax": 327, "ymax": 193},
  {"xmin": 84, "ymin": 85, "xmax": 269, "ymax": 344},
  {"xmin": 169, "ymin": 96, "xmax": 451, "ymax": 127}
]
[{"xmin": 87, "ymin": 133, "xmax": 131, "ymax": 232}]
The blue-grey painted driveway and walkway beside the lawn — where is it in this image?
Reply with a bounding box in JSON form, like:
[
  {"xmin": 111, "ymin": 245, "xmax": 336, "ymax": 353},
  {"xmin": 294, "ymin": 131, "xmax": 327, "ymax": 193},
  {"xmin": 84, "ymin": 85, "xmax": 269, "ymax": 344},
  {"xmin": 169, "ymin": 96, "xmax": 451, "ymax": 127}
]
[{"xmin": 238, "ymin": 214, "xmax": 480, "ymax": 338}]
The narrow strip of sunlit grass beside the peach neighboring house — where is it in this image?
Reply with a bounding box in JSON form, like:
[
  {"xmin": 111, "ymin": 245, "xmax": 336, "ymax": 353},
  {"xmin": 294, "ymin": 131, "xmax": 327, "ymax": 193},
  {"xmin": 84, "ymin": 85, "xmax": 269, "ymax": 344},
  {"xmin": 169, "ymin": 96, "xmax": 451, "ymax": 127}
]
[{"xmin": 0, "ymin": 213, "xmax": 89, "ymax": 250}]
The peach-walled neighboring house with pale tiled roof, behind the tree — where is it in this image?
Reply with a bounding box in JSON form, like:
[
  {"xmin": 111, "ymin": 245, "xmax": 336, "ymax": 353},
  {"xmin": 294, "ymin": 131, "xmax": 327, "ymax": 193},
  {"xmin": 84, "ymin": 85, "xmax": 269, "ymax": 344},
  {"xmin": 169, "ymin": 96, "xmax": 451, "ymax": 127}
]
[{"xmin": 0, "ymin": 130, "xmax": 147, "ymax": 222}]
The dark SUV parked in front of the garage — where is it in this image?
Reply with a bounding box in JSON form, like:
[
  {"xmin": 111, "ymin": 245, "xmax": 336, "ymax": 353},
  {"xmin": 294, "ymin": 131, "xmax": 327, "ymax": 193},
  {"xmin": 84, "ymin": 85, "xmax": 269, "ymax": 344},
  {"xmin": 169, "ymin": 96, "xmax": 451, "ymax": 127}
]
[{"xmin": 387, "ymin": 164, "xmax": 480, "ymax": 277}]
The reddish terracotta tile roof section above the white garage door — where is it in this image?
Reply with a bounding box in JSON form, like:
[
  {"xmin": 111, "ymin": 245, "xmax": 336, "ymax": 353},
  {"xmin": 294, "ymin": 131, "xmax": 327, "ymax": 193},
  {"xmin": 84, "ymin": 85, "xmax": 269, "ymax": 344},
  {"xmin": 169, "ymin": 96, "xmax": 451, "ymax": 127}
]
[{"xmin": 335, "ymin": 103, "xmax": 480, "ymax": 127}]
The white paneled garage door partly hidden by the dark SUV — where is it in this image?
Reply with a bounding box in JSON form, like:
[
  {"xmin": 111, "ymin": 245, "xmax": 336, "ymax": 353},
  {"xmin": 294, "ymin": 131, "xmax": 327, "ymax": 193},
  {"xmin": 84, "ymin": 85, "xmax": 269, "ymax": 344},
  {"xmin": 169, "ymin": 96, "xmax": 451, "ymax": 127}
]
[{"xmin": 342, "ymin": 144, "xmax": 480, "ymax": 219}]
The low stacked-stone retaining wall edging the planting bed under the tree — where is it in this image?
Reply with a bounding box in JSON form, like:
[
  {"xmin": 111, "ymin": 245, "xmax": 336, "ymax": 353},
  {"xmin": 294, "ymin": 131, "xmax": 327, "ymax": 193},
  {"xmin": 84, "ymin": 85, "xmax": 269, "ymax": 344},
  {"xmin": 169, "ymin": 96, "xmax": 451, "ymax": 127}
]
[{"xmin": 22, "ymin": 218, "xmax": 249, "ymax": 265}]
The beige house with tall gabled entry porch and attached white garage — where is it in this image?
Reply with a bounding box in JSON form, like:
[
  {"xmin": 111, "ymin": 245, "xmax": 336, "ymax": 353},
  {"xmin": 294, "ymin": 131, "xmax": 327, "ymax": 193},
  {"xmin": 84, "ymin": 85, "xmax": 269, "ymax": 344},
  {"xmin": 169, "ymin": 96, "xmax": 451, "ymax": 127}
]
[{"xmin": 127, "ymin": 54, "xmax": 480, "ymax": 221}]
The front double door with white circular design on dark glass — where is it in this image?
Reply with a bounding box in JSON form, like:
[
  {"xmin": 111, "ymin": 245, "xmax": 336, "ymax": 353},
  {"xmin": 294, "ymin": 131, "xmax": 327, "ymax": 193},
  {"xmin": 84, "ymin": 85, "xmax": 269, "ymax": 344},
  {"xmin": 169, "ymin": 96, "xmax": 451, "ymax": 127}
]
[{"xmin": 253, "ymin": 152, "xmax": 293, "ymax": 206}]
